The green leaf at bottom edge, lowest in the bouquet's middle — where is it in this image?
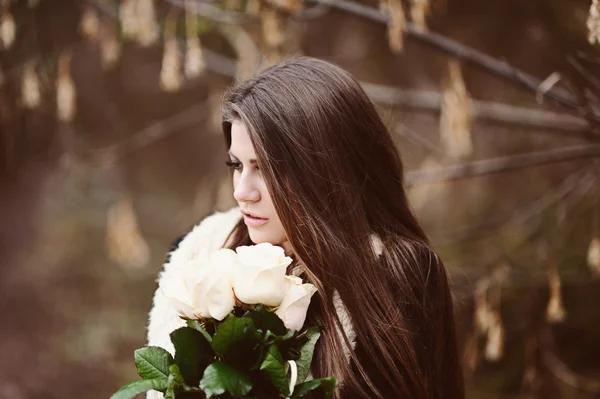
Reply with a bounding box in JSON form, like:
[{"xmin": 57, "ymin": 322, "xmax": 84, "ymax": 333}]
[{"xmin": 200, "ymin": 362, "xmax": 252, "ymax": 398}]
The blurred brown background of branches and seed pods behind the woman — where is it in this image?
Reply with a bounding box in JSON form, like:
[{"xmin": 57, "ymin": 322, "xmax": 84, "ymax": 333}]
[{"xmin": 0, "ymin": 0, "xmax": 600, "ymax": 399}]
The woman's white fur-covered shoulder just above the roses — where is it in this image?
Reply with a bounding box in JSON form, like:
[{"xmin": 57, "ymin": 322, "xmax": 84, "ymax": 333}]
[{"xmin": 165, "ymin": 207, "xmax": 241, "ymax": 269}]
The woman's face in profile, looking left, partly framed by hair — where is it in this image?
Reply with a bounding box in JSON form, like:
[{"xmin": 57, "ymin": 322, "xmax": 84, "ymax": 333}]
[{"xmin": 229, "ymin": 120, "xmax": 289, "ymax": 251}]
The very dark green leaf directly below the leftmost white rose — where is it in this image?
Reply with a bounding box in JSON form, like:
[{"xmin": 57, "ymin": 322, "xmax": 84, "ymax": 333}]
[{"xmin": 171, "ymin": 327, "xmax": 214, "ymax": 386}]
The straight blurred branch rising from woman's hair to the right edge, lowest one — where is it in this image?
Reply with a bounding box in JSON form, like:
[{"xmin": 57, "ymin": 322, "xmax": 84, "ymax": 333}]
[{"xmin": 406, "ymin": 144, "xmax": 600, "ymax": 185}]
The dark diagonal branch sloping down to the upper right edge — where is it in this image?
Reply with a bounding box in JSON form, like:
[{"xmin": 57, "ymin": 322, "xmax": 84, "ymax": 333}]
[{"xmin": 307, "ymin": 0, "xmax": 600, "ymax": 121}]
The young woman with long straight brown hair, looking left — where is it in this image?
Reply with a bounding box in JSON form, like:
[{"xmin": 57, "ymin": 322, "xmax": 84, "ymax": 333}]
[{"xmin": 148, "ymin": 57, "xmax": 464, "ymax": 399}]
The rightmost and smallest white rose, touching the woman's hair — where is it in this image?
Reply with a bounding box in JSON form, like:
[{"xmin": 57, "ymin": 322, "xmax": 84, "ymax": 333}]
[{"xmin": 275, "ymin": 276, "xmax": 317, "ymax": 331}]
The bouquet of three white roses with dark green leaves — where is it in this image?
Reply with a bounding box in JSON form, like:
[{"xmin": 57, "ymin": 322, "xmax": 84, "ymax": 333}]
[{"xmin": 112, "ymin": 243, "xmax": 337, "ymax": 399}]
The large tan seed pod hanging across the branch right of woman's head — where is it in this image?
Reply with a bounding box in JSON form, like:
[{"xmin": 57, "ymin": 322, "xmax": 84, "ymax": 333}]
[{"xmin": 440, "ymin": 60, "xmax": 473, "ymax": 159}]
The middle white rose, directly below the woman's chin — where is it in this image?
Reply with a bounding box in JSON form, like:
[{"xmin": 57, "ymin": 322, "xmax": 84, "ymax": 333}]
[{"xmin": 233, "ymin": 243, "xmax": 292, "ymax": 306}]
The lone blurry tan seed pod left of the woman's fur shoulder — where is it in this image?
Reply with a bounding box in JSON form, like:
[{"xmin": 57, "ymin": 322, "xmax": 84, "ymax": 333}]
[{"xmin": 106, "ymin": 198, "xmax": 150, "ymax": 269}]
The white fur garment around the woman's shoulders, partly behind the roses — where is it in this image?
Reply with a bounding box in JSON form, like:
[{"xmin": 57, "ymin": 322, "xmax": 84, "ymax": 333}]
[{"xmin": 147, "ymin": 208, "xmax": 381, "ymax": 399}]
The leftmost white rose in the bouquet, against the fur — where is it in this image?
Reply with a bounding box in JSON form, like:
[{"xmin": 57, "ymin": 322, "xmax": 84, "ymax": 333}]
[{"xmin": 160, "ymin": 249, "xmax": 236, "ymax": 320}]
